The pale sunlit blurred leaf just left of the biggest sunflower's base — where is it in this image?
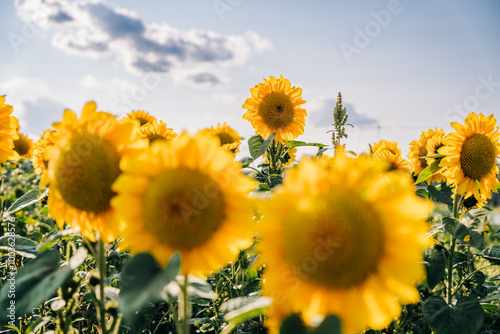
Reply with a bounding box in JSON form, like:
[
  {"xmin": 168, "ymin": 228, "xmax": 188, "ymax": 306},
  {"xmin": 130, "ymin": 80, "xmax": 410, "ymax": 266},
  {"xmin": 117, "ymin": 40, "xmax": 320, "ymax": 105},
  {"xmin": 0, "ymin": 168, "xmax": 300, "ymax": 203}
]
[{"xmin": 221, "ymin": 297, "xmax": 273, "ymax": 323}]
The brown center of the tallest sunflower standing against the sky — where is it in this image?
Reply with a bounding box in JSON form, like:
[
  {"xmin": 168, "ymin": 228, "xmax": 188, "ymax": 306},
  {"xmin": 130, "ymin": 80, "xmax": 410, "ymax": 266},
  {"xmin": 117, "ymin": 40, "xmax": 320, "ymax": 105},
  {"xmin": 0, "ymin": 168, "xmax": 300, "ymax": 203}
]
[{"xmin": 259, "ymin": 92, "xmax": 294, "ymax": 130}]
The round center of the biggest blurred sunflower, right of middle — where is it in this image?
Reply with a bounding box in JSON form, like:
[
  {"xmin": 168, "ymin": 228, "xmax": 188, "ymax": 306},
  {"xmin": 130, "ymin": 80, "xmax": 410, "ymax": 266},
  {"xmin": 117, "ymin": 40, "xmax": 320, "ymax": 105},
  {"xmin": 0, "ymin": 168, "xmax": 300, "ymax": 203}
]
[{"xmin": 284, "ymin": 192, "xmax": 385, "ymax": 289}]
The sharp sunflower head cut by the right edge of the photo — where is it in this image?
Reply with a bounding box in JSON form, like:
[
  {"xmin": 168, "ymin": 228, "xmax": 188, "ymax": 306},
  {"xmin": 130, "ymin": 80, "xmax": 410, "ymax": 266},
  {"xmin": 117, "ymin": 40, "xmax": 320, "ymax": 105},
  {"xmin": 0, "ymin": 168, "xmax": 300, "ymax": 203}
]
[{"xmin": 438, "ymin": 113, "xmax": 500, "ymax": 201}]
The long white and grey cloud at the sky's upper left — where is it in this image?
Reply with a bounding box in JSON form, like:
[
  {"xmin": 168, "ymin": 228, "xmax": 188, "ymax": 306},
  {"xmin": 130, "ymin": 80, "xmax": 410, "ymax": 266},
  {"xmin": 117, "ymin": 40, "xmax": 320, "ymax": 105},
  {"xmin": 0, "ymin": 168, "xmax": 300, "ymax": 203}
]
[{"xmin": 16, "ymin": 0, "xmax": 272, "ymax": 86}]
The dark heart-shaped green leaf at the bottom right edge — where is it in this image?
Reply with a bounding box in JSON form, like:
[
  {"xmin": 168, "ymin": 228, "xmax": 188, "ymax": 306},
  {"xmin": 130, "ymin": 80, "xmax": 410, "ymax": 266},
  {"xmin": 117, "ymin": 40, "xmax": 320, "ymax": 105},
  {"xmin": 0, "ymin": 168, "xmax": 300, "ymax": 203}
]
[{"xmin": 422, "ymin": 296, "xmax": 484, "ymax": 334}]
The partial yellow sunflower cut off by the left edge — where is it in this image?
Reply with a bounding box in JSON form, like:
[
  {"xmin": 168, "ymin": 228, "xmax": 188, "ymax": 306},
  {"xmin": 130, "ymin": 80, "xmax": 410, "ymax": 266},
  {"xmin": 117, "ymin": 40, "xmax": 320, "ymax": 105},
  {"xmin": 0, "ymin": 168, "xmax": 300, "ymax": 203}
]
[{"xmin": 0, "ymin": 95, "xmax": 19, "ymax": 164}]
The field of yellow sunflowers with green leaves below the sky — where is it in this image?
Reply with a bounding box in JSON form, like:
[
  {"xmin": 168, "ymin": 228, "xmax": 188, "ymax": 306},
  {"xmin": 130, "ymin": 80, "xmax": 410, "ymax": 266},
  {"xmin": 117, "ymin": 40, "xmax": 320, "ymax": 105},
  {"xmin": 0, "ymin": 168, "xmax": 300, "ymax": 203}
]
[{"xmin": 0, "ymin": 76, "xmax": 500, "ymax": 334}]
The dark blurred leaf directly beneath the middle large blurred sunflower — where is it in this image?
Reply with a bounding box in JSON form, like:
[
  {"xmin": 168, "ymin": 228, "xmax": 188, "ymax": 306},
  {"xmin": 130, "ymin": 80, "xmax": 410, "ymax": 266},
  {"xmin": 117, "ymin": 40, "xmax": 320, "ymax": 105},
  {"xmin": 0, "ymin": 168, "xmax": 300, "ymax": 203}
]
[{"xmin": 119, "ymin": 253, "xmax": 180, "ymax": 322}]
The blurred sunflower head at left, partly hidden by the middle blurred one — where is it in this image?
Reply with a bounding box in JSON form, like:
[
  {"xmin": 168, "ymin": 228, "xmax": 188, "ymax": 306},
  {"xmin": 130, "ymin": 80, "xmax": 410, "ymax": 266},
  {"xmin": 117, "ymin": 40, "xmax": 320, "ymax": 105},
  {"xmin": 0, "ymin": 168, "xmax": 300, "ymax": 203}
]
[{"xmin": 45, "ymin": 102, "xmax": 148, "ymax": 242}]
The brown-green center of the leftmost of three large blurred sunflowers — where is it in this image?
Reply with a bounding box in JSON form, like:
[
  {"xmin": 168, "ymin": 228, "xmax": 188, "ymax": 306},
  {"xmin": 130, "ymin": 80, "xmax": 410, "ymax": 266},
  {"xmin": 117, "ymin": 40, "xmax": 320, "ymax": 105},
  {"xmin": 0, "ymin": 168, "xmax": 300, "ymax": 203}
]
[{"xmin": 53, "ymin": 133, "xmax": 120, "ymax": 213}]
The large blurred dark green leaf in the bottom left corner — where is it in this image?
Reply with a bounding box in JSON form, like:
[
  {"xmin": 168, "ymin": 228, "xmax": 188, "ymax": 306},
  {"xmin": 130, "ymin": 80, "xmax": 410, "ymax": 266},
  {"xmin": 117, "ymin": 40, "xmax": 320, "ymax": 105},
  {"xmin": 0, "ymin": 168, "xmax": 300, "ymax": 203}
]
[{"xmin": 0, "ymin": 248, "xmax": 86, "ymax": 324}]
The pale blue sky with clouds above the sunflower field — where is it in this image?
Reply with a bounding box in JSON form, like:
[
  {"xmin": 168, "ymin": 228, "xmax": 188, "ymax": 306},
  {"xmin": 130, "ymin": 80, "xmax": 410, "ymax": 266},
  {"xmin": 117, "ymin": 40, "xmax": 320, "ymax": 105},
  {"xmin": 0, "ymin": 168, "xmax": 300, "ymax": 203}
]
[{"xmin": 0, "ymin": 0, "xmax": 500, "ymax": 156}]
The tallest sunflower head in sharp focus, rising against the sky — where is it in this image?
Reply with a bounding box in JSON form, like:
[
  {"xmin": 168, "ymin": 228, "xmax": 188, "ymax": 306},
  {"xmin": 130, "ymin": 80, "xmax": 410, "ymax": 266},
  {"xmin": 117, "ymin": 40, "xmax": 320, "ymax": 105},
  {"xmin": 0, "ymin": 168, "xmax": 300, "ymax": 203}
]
[{"xmin": 243, "ymin": 76, "xmax": 307, "ymax": 143}]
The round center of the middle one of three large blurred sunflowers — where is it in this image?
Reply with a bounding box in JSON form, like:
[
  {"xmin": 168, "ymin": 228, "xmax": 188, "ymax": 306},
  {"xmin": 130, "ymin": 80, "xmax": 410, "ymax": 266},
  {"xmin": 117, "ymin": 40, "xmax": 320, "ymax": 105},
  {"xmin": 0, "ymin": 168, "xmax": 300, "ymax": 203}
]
[{"xmin": 143, "ymin": 168, "xmax": 226, "ymax": 250}]
